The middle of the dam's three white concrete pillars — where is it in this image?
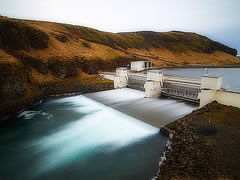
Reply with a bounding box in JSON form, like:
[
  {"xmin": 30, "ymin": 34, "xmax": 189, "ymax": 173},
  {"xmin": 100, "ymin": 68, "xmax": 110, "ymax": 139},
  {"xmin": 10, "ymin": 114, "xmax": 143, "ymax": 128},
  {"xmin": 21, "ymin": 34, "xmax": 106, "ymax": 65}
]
[{"xmin": 144, "ymin": 70, "xmax": 163, "ymax": 98}]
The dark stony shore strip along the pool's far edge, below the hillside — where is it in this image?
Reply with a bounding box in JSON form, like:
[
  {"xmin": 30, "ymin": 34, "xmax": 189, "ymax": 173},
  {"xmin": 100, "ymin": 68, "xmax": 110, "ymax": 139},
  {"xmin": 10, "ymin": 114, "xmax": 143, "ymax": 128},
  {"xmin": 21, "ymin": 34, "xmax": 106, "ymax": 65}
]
[{"xmin": 0, "ymin": 78, "xmax": 113, "ymax": 122}]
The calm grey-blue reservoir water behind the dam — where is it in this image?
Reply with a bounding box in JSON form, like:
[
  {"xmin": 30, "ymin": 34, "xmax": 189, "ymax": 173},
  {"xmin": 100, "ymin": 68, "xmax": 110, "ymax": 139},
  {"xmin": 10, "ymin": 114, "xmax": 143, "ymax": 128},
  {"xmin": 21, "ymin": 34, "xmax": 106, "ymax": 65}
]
[{"xmin": 163, "ymin": 68, "xmax": 240, "ymax": 92}]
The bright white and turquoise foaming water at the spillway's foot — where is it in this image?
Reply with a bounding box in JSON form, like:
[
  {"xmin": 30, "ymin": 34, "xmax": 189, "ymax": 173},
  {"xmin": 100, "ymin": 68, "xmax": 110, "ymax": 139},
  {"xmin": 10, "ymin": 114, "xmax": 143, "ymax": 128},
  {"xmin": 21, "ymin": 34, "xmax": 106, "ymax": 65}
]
[{"xmin": 26, "ymin": 96, "xmax": 159, "ymax": 175}]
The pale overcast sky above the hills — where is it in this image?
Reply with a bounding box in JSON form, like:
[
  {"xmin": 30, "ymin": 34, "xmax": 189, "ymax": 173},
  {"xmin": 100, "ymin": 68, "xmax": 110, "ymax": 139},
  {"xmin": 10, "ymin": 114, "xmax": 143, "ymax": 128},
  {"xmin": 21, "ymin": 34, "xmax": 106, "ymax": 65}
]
[{"xmin": 0, "ymin": 0, "xmax": 240, "ymax": 54}]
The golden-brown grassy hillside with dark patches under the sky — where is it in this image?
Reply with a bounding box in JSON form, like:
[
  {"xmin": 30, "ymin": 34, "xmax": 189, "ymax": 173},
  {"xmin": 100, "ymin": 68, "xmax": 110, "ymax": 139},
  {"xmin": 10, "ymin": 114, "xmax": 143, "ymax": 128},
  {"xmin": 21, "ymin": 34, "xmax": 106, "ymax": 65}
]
[{"xmin": 0, "ymin": 17, "xmax": 239, "ymax": 118}]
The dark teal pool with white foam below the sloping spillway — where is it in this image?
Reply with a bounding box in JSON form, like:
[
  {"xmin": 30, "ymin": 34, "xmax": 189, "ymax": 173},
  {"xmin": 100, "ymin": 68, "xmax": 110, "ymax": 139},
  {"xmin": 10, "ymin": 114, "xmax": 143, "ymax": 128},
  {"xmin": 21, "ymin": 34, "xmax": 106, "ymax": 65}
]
[{"xmin": 0, "ymin": 93, "xmax": 167, "ymax": 180}]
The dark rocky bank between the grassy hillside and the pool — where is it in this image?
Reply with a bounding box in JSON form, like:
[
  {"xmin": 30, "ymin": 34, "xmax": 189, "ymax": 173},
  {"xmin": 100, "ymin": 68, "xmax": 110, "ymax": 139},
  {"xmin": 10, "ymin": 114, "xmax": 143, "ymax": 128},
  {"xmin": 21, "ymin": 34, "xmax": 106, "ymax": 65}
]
[{"xmin": 0, "ymin": 75, "xmax": 113, "ymax": 121}]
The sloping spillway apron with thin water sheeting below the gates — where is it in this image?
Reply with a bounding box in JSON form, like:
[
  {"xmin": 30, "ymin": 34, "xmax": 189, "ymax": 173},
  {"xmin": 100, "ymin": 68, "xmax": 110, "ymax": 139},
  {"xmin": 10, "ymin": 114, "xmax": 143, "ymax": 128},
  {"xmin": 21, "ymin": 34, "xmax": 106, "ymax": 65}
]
[{"xmin": 84, "ymin": 88, "xmax": 198, "ymax": 128}]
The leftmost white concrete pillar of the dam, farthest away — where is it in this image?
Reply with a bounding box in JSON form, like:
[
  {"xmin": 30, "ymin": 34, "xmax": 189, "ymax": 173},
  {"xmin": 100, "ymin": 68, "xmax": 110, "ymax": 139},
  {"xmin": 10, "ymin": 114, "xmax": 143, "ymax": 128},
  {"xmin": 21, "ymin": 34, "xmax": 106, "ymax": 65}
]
[{"xmin": 114, "ymin": 68, "xmax": 128, "ymax": 89}]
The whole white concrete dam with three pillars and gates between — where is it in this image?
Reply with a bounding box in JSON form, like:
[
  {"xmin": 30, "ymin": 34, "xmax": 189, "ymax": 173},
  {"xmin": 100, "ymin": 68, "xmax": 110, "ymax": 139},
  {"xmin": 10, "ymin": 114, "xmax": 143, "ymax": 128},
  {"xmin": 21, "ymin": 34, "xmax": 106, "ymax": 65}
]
[{"xmin": 101, "ymin": 61, "xmax": 240, "ymax": 107}]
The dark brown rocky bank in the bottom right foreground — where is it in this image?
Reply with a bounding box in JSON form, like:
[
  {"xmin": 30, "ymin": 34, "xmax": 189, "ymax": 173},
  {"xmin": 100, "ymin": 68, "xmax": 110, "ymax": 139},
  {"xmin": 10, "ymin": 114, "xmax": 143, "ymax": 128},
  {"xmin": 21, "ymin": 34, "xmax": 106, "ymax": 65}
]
[{"xmin": 158, "ymin": 102, "xmax": 240, "ymax": 180}]
